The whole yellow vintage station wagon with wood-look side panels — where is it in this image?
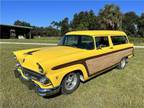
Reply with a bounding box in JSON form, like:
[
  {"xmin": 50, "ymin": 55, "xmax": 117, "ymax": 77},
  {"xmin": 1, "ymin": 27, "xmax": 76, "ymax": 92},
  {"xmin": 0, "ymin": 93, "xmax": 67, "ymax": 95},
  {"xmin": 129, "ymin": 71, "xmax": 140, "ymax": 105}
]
[{"xmin": 14, "ymin": 30, "xmax": 134, "ymax": 96}]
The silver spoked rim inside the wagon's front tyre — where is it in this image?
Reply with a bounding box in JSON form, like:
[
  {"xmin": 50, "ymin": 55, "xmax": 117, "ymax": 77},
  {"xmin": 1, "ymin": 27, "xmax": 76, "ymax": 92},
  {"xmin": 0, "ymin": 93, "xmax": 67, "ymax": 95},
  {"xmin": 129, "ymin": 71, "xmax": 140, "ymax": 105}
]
[{"xmin": 65, "ymin": 73, "xmax": 78, "ymax": 90}]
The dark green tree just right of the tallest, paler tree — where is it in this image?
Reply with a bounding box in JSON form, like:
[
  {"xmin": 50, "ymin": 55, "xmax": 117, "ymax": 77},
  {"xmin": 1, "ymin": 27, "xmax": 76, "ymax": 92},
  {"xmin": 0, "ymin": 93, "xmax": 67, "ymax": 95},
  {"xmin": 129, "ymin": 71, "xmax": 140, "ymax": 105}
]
[{"xmin": 122, "ymin": 12, "xmax": 139, "ymax": 36}]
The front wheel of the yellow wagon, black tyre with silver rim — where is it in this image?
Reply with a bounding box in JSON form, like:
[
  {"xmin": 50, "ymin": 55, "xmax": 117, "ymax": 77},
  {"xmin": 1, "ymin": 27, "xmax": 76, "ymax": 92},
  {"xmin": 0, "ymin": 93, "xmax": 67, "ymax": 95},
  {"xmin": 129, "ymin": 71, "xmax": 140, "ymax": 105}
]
[{"xmin": 61, "ymin": 72, "xmax": 80, "ymax": 94}]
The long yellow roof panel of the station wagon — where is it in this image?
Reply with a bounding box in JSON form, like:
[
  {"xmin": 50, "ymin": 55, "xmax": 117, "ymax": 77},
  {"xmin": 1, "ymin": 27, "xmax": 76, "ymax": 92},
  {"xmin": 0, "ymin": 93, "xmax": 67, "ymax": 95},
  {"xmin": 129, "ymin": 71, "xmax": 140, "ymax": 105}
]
[{"xmin": 66, "ymin": 30, "xmax": 126, "ymax": 37}]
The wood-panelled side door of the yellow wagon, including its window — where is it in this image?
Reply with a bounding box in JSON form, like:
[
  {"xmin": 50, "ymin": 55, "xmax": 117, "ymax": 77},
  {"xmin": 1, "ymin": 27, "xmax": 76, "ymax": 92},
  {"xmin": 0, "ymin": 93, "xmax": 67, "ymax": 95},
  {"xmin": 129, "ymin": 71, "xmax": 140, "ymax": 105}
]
[{"xmin": 86, "ymin": 36, "xmax": 115, "ymax": 75}]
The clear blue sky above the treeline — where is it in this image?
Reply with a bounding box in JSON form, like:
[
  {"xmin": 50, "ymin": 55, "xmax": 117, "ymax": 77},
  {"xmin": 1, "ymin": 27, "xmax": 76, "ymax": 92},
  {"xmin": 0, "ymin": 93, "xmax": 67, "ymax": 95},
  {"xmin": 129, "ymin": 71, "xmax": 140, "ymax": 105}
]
[{"xmin": 0, "ymin": 0, "xmax": 144, "ymax": 26}]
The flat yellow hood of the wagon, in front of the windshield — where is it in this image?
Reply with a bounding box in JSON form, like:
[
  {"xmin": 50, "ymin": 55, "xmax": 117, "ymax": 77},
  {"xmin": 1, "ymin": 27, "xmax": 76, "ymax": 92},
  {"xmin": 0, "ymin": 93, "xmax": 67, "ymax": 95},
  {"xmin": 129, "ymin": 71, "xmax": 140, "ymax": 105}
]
[{"xmin": 25, "ymin": 46, "xmax": 83, "ymax": 62}]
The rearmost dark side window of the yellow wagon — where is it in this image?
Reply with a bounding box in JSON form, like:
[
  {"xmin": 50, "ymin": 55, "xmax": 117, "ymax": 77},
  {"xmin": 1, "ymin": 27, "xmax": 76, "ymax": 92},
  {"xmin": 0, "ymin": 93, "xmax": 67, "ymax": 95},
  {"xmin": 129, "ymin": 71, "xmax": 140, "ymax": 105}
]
[{"xmin": 111, "ymin": 36, "xmax": 128, "ymax": 45}]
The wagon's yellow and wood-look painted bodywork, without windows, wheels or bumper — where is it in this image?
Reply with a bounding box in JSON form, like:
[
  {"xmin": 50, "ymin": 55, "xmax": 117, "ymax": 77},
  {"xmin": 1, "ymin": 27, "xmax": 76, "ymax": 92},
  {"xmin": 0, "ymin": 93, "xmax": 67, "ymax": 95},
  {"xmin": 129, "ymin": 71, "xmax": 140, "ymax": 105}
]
[{"xmin": 14, "ymin": 30, "xmax": 133, "ymax": 94}]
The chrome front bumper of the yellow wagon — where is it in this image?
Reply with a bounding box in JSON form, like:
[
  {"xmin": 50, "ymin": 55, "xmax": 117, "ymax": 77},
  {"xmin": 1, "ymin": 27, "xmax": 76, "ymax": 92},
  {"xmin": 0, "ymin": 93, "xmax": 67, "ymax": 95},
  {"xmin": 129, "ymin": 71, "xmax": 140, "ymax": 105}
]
[{"xmin": 14, "ymin": 68, "xmax": 60, "ymax": 97}]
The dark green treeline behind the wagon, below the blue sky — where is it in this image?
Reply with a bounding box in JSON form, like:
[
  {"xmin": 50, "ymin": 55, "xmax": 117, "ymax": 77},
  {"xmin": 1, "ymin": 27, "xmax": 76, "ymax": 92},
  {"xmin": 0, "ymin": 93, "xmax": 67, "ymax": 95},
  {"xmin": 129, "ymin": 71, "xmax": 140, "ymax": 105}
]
[{"xmin": 14, "ymin": 4, "xmax": 144, "ymax": 37}]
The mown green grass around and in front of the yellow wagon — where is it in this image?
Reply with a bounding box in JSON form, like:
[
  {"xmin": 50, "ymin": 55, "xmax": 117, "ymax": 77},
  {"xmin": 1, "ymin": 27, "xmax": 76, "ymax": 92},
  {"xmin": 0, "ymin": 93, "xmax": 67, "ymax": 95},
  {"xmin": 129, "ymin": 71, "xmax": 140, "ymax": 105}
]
[{"xmin": 0, "ymin": 45, "xmax": 144, "ymax": 108}]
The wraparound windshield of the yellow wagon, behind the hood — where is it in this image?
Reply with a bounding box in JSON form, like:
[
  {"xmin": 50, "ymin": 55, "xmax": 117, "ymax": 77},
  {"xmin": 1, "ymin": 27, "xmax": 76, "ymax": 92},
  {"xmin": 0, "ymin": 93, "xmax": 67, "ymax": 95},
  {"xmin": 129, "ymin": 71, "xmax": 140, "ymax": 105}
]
[{"xmin": 58, "ymin": 35, "xmax": 94, "ymax": 50}]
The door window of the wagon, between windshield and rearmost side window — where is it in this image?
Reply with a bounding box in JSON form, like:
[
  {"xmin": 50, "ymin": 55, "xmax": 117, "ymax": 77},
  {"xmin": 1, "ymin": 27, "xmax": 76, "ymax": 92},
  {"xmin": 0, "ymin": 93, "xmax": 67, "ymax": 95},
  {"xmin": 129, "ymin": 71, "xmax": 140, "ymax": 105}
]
[{"xmin": 95, "ymin": 37, "xmax": 109, "ymax": 48}]
